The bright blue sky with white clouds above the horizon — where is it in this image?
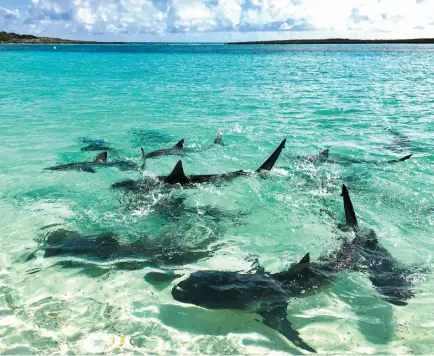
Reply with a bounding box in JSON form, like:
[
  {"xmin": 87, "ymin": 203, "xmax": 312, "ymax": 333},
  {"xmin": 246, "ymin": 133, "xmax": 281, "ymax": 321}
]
[{"xmin": 0, "ymin": 0, "xmax": 434, "ymax": 42}]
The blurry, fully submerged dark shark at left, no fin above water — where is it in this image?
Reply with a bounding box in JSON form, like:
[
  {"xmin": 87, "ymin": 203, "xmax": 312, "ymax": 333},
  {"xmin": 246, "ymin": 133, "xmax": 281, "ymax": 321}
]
[{"xmin": 26, "ymin": 204, "xmax": 232, "ymax": 270}]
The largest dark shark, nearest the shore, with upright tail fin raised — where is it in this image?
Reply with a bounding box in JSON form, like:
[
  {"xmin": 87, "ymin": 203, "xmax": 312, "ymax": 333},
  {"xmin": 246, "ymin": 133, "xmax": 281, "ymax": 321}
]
[{"xmin": 171, "ymin": 185, "xmax": 414, "ymax": 352}]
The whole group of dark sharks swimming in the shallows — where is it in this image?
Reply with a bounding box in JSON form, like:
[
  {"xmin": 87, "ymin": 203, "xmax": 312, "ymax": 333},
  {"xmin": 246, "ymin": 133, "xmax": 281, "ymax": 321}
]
[{"xmin": 34, "ymin": 133, "xmax": 420, "ymax": 353}]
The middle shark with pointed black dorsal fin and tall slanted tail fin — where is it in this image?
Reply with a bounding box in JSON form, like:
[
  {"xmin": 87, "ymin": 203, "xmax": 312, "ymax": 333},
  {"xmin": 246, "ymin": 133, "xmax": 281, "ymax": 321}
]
[{"xmin": 112, "ymin": 139, "xmax": 286, "ymax": 191}]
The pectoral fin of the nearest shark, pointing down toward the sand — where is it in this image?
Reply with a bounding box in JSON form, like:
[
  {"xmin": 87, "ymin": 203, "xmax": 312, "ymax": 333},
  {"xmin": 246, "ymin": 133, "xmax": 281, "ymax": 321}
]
[{"xmin": 258, "ymin": 304, "xmax": 316, "ymax": 353}]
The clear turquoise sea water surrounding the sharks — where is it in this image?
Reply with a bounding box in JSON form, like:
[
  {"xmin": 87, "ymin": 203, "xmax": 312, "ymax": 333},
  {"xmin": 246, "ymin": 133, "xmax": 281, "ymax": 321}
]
[{"xmin": 0, "ymin": 44, "xmax": 434, "ymax": 354}]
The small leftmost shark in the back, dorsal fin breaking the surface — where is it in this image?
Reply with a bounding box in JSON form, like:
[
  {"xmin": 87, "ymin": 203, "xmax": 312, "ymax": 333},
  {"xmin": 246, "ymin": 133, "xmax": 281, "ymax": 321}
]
[{"xmin": 45, "ymin": 150, "xmax": 145, "ymax": 173}]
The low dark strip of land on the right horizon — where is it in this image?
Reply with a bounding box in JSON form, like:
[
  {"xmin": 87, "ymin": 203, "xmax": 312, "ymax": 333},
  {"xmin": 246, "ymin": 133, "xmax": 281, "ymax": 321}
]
[{"xmin": 227, "ymin": 38, "xmax": 434, "ymax": 45}]
